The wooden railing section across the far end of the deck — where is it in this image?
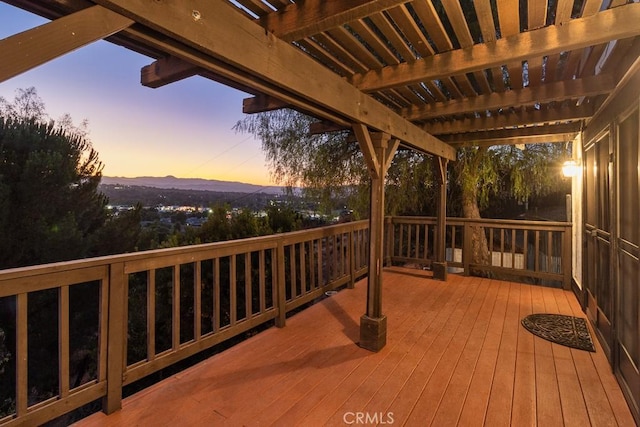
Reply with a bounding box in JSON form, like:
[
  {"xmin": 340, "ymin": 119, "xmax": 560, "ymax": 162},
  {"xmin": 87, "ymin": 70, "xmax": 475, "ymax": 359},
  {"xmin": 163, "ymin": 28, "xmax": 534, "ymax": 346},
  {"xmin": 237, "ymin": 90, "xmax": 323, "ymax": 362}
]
[{"xmin": 385, "ymin": 217, "xmax": 571, "ymax": 289}]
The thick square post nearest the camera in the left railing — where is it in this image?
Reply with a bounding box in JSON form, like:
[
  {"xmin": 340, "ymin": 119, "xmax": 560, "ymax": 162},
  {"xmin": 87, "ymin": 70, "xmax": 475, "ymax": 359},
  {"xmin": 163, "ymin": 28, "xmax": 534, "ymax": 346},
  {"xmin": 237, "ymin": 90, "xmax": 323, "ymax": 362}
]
[{"xmin": 100, "ymin": 262, "xmax": 127, "ymax": 414}]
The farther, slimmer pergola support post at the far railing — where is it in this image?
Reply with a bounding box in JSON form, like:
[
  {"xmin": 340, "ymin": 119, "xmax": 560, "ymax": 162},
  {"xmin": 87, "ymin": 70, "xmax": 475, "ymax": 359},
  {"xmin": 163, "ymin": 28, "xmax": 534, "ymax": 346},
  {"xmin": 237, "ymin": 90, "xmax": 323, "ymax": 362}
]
[{"xmin": 431, "ymin": 157, "xmax": 453, "ymax": 281}]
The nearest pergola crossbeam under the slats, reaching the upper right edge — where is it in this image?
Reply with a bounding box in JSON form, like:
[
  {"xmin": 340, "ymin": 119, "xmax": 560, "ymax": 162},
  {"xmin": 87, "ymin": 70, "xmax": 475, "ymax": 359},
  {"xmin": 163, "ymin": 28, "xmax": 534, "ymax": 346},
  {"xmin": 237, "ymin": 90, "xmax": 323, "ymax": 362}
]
[{"xmin": 350, "ymin": 3, "xmax": 640, "ymax": 92}]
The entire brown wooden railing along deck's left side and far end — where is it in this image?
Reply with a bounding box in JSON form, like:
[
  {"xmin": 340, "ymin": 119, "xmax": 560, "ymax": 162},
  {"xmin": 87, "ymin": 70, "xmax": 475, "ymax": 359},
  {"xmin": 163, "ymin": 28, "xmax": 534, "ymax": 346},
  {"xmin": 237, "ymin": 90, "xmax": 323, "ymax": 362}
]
[{"xmin": 0, "ymin": 217, "xmax": 571, "ymax": 426}]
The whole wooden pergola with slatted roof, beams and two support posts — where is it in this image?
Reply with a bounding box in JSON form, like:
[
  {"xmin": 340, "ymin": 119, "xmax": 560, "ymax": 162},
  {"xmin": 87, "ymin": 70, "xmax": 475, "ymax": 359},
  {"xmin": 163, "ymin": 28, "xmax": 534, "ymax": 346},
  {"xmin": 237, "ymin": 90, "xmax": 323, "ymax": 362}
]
[{"xmin": 0, "ymin": 0, "xmax": 640, "ymax": 350}]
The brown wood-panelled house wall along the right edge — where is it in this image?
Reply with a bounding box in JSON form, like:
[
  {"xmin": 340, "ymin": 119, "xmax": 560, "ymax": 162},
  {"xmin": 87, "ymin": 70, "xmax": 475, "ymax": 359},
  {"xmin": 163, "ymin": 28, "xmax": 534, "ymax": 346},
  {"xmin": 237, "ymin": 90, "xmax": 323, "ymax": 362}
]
[{"xmin": 574, "ymin": 67, "xmax": 640, "ymax": 423}]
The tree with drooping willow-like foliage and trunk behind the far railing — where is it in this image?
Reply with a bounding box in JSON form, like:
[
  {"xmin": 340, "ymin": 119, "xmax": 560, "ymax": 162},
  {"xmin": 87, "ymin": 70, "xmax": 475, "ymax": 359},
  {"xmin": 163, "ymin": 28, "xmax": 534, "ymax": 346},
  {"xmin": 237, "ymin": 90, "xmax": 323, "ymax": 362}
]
[{"xmin": 235, "ymin": 110, "xmax": 570, "ymax": 263}]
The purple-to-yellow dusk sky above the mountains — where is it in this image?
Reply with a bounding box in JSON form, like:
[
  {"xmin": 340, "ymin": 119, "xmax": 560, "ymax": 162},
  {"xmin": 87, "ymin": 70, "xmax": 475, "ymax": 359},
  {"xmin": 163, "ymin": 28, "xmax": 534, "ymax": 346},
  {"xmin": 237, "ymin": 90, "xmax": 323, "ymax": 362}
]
[{"xmin": 0, "ymin": 2, "xmax": 272, "ymax": 185}]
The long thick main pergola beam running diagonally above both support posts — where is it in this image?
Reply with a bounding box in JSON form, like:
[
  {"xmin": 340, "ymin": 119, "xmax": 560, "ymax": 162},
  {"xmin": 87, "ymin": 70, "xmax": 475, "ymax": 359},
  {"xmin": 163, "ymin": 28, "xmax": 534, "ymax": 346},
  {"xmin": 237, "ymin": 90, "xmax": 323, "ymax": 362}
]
[{"xmin": 96, "ymin": 0, "xmax": 455, "ymax": 160}]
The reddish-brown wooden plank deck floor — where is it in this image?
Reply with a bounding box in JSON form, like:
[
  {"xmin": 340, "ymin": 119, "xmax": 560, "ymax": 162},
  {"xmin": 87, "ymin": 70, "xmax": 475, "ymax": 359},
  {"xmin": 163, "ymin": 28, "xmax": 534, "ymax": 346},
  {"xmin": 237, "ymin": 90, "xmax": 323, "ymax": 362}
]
[{"xmin": 79, "ymin": 270, "xmax": 635, "ymax": 427}]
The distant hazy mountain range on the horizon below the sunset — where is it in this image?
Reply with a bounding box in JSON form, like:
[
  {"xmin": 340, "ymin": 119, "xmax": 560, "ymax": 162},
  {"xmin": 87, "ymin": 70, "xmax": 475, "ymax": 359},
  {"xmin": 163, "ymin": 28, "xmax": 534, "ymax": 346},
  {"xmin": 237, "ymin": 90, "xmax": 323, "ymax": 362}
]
[{"xmin": 102, "ymin": 175, "xmax": 282, "ymax": 194}]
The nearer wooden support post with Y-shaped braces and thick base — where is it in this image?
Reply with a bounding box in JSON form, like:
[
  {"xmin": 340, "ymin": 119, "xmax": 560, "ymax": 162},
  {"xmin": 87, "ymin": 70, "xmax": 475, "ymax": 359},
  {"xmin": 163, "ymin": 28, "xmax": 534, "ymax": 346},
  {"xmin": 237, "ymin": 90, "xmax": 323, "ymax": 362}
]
[{"xmin": 353, "ymin": 124, "xmax": 399, "ymax": 351}]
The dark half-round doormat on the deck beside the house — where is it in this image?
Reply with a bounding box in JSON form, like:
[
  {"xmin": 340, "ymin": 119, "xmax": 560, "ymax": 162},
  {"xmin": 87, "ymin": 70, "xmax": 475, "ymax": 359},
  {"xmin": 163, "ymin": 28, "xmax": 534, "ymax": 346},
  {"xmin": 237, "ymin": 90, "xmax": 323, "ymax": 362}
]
[{"xmin": 522, "ymin": 314, "xmax": 596, "ymax": 352}]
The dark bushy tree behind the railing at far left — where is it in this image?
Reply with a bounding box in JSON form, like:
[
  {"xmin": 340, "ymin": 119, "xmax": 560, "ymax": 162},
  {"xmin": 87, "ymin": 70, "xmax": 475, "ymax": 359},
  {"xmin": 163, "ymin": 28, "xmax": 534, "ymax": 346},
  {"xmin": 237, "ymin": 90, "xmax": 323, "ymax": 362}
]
[{"xmin": 0, "ymin": 88, "xmax": 107, "ymax": 268}]
